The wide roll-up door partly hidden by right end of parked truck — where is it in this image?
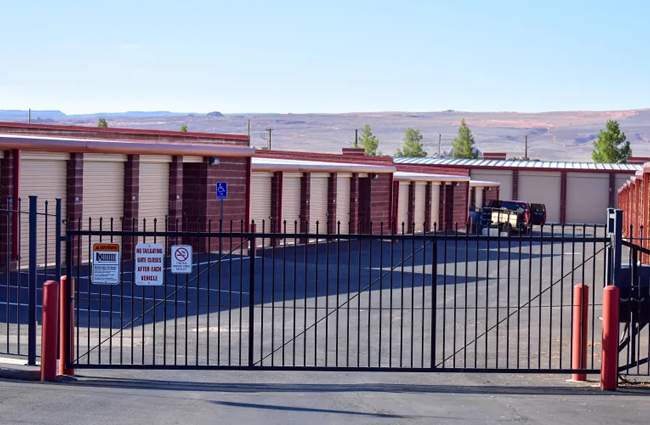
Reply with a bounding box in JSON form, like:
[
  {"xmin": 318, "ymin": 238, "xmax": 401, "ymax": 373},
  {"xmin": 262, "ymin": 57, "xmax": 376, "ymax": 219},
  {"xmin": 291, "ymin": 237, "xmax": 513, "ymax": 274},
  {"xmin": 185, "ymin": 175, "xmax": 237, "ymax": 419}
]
[{"xmin": 516, "ymin": 170, "xmax": 562, "ymax": 223}]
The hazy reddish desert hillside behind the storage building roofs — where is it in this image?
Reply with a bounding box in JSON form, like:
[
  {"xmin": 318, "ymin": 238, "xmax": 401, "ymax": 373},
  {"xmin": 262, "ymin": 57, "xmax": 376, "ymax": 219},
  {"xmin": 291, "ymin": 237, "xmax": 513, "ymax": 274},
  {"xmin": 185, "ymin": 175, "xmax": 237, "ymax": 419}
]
[{"xmin": 3, "ymin": 109, "xmax": 650, "ymax": 161}]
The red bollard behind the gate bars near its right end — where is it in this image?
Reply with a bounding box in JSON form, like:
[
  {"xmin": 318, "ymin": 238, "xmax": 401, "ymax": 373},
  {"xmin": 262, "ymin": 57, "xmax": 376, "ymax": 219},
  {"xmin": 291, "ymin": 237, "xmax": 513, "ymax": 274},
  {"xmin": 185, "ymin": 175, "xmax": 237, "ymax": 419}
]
[{"xmin": 571, "ymin": 283, "xmax": 589, "ymax": 381}]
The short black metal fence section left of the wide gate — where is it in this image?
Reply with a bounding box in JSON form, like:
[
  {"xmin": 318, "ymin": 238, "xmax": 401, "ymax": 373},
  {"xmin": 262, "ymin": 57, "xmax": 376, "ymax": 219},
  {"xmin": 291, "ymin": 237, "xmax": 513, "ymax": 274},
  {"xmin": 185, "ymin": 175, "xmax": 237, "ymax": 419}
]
[{"xmin": 0, "ymin": 196, "xmax": 62, "ymax": 365}]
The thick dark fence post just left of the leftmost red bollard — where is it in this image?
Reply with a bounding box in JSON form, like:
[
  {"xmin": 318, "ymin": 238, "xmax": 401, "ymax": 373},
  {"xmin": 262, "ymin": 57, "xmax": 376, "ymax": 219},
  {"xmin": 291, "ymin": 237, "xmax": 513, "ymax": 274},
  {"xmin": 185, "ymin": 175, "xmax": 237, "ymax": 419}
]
[{"xmin": 27, "ymin": 196, "xmax": 38, "ymax": 366}]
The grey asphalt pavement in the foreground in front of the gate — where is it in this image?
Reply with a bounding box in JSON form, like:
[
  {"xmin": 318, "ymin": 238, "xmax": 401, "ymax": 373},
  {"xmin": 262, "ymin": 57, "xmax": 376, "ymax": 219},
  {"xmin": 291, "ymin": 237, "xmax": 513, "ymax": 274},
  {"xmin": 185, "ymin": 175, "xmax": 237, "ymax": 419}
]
[{"xmin": 0, "ymin": 371, "xmax": 650, "ymax": 425}]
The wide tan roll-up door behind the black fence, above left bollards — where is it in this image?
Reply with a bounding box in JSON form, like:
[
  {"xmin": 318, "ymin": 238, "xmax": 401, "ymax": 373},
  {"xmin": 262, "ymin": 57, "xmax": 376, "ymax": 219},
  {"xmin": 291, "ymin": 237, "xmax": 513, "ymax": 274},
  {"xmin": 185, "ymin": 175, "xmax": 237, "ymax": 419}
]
[{"xmin": 19, "ymin": 152, "xmax": 69, "ymax": 268}]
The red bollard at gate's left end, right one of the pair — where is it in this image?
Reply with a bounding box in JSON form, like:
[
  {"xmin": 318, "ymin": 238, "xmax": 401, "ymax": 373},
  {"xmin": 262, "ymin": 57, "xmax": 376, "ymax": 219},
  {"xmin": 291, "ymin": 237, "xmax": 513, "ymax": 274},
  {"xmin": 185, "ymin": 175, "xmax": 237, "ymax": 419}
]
[{"xmin": 41, "ymin": 280, "xmax": 59, "ymax": 381}]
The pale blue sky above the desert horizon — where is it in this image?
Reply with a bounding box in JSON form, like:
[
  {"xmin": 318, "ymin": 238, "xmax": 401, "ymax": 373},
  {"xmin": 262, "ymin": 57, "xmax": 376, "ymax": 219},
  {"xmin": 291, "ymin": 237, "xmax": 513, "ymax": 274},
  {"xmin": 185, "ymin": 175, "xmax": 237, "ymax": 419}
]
[{"xmin": 0, "ymin": 0, "xmax": 650, "ymax": 113}]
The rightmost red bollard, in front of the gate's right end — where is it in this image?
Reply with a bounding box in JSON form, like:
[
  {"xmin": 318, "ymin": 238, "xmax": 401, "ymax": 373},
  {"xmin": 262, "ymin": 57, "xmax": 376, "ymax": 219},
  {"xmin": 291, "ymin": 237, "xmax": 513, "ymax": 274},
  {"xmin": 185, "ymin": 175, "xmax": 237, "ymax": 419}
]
[{"xmin": 600, "ymin": 286, "xmax": 620, "ymax": 391}]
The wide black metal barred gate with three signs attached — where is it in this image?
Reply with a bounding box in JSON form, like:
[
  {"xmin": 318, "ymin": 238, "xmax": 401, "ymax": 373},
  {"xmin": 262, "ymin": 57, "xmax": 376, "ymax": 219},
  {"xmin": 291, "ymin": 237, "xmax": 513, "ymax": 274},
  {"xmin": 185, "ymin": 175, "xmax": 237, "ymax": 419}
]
[{"xmin": 67, "ymin": 220, "xmax": 610, "ymax": 373}]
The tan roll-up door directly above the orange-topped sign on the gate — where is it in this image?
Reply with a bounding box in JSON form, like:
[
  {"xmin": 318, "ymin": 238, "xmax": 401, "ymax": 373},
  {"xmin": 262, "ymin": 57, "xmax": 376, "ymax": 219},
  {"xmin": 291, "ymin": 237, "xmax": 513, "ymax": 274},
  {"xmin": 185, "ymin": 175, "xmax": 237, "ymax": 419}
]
[{"xmin": 82, "ymin": 154, "xmax": 126, "ymax": 262}]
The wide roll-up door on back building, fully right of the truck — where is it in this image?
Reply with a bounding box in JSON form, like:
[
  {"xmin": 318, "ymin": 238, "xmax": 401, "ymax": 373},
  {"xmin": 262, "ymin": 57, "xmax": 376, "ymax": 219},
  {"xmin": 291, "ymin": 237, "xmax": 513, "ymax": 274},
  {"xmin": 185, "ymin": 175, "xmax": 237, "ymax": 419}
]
[{"xmin": 566, "ymin": 173, "xmax": 609, "ymax": 224}]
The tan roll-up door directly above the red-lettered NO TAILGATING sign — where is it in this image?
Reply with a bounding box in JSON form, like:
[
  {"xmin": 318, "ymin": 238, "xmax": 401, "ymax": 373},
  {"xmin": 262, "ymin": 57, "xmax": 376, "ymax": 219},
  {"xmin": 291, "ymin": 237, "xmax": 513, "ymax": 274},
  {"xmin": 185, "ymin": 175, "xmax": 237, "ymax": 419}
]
[{"xmin": 138, "ymin": 155, "xmax": 172, "ymax": 232}]
